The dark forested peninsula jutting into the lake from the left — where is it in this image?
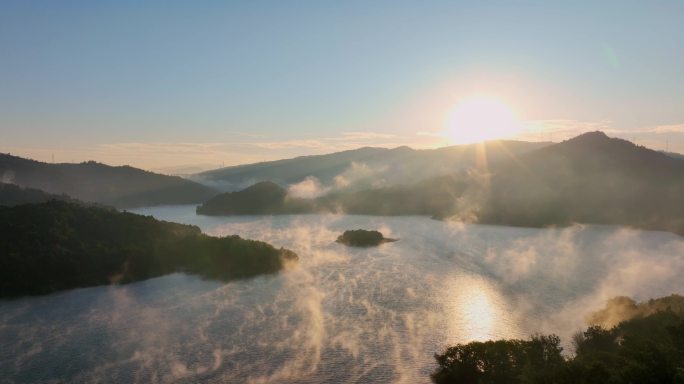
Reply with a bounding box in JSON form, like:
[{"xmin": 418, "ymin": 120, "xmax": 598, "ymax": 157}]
[{"xmin": 0, "ymin": 201, "xmax": 297, "ymax": 297}]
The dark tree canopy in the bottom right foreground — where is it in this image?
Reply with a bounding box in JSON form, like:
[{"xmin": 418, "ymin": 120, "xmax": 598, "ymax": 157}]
[{"xmin": 431, "ymin": 295, "xmax": 684, "ymax": 384}]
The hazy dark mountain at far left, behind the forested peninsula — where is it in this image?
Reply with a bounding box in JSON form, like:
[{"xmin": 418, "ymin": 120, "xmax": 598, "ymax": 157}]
[{"xmin": 0, "ymin": 154, "xmax": 217, "ymax": 207}]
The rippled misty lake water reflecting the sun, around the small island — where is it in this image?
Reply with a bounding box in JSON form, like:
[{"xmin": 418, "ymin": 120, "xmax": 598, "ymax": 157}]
[{"xmin": 0, "ymin": 206, "xmax": 684, "ymax": 383}]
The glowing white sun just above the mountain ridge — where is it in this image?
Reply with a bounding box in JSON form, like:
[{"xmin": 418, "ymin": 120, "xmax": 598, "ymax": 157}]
[{"xmin": 445, "ymin": 96, "xmax": 522, "ymax": 144}]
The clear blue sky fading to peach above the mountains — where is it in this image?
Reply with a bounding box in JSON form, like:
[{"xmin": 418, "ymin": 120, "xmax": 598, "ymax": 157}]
[{"xmin": 0, "ymin": 0, "xmax": 684, "ymax": 173}]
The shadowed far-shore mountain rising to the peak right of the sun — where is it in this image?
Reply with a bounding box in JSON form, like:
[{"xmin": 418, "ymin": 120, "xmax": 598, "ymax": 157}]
[{"xmin": 198, "ymin": 132, "xmax": 684, "ymax": 234}]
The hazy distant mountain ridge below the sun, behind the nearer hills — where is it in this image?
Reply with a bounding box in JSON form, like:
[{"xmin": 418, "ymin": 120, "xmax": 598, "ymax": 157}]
[{"xmin": 190, "ymin": 141, "xmax": 549, "ymax": 191}]
